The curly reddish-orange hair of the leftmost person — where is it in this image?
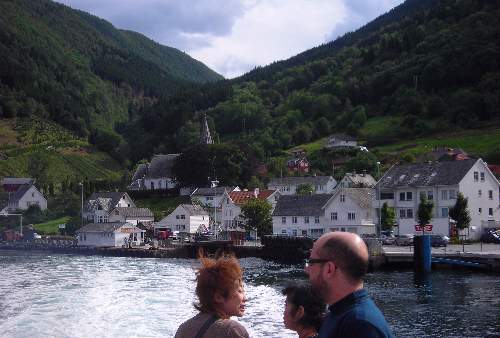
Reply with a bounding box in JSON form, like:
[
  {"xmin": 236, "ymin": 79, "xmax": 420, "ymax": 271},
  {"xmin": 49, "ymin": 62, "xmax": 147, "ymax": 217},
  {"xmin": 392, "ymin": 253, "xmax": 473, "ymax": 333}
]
[{"xmin": 194, "ymin": 256, "xmax": 243, "ymax": 316}]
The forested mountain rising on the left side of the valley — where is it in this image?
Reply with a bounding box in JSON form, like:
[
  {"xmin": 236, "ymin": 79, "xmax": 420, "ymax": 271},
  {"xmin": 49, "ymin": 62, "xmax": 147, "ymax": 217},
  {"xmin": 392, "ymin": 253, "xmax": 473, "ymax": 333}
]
[{"xmin": 0, "ymin": 0, "xmax": 222, "ymax": 137}]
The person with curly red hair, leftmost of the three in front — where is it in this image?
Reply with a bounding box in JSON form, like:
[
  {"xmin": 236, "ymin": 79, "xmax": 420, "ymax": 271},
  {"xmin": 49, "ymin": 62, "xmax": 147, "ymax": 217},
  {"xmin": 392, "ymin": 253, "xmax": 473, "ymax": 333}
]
[{"xmin": 175, "ymin": 256, "xmax": 249, "ymax": 338}]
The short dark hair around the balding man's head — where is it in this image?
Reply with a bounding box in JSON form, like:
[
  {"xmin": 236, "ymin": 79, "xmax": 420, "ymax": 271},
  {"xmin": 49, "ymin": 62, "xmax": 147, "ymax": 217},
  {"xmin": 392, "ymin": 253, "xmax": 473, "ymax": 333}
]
[{"xmin": 320, "ymin": 237, "xmax": 368, "ymax": 282}]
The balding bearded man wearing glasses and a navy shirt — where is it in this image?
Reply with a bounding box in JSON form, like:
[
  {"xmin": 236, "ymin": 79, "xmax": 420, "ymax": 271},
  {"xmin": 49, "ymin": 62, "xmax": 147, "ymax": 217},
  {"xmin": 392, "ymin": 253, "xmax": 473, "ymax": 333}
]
[{"xmin": 305, "ymin": 232, "xmax": 392, "ymax": 338}]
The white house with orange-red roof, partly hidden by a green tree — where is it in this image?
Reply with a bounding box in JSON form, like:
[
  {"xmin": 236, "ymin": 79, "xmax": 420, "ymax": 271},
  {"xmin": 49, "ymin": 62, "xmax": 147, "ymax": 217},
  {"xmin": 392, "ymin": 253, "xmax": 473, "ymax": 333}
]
[{"xmin": 221, "ymin": 188, "xmax": 280, "ymax": 243}]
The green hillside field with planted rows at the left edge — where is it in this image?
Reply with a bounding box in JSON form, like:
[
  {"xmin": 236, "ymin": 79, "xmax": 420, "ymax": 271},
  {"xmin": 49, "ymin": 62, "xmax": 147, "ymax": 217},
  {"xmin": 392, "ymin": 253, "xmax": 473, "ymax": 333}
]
[{"xmin": 0, "ymin": 119, "xmax": 122, "ymax": 182}]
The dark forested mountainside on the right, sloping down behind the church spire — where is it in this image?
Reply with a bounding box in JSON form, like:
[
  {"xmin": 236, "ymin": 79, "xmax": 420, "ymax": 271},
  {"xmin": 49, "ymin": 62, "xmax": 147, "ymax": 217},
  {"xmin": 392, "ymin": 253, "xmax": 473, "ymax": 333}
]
[{"xmin": 126, "ymin": 0, "xmax": 500, "ymax": 185}]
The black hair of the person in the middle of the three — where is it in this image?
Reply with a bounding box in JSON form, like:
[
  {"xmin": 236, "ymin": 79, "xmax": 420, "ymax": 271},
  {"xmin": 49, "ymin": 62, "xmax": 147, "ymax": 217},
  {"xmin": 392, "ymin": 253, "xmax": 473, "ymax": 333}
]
[{"xmin": 282, "ymin": 283, "xmax": 326, "ymax": 330}]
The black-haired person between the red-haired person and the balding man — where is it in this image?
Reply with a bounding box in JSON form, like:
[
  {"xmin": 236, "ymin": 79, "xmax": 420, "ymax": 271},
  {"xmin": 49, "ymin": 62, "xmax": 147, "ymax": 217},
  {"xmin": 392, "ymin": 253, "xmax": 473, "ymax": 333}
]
[{"xmin": 282, "ymin": 283, "xmax": 326, "ymax": 338}]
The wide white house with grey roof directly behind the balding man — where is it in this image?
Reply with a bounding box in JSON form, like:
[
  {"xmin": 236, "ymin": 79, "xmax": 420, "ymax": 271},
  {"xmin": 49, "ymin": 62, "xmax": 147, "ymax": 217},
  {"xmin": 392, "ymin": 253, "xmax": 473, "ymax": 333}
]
[{"xmin": 273, "ymin": 188, "xmax": 375, "ymax": 238}]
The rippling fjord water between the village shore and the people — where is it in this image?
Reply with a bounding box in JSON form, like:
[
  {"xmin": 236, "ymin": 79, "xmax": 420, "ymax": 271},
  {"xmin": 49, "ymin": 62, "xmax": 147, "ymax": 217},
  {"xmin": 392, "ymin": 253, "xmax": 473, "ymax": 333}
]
[{"xmin": 0, "ymin": 251, "xmax": 500, "ymax": 338}]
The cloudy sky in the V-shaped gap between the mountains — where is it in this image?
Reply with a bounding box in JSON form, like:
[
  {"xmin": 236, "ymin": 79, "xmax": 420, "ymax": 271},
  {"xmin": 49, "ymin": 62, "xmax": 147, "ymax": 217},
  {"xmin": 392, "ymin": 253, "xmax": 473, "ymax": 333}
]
[{"xmin": 56, "ymin": 0, "xmax": 403, "ymax": 78}]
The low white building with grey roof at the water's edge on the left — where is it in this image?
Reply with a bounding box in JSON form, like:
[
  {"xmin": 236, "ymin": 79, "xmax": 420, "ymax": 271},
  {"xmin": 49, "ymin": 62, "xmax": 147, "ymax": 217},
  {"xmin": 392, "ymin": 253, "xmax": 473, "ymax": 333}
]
[{"xmin": 76, "ymin": 222, "xmax": 145, "ymax": 247}]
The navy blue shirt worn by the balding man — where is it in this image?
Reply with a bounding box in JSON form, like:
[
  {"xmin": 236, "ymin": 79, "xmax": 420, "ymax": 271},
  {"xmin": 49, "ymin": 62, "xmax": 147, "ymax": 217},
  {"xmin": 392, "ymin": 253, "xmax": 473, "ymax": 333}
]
[{"xmin": 319, "ymin": 289, "xmax": 392, "ymax": 338}]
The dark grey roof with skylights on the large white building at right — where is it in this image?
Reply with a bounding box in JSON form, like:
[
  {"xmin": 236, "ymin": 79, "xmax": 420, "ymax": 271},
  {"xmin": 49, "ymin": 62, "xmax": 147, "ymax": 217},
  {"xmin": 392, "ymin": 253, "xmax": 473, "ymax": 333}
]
[{"xmin": 379, "ymin": 159, "xmax": 478, "ymax": 189}]
